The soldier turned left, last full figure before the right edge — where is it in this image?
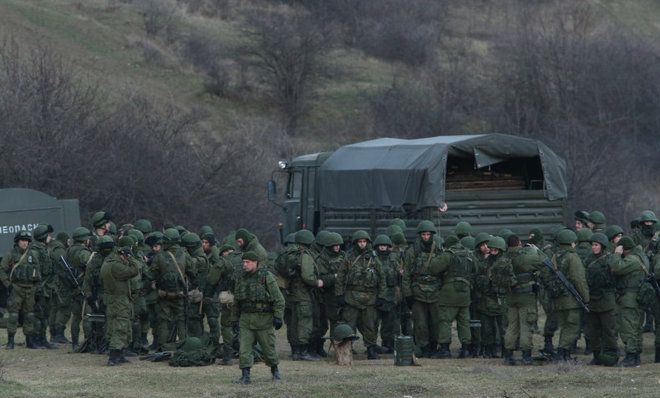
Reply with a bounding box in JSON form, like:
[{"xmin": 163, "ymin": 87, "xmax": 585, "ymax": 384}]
[{"xmin": 610, "ymin": 236, "xmax": 648, "ymax": 367}]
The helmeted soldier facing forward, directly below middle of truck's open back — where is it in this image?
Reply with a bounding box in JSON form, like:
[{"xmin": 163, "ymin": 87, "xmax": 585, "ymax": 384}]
[{"xmin": 474, "ymin": 235, "xmax": 515, "ymax": 358}]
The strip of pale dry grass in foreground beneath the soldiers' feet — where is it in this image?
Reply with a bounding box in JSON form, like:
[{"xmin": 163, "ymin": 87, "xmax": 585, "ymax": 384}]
[{"xmin": 0, "ymin": 324, "xmax": 660, "ymax": 398}]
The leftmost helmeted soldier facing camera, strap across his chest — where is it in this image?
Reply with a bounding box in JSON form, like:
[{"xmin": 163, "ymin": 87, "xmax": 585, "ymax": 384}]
[{"xmin": 0, "ymin": 231, "xmax": 41, "ymax": 350}]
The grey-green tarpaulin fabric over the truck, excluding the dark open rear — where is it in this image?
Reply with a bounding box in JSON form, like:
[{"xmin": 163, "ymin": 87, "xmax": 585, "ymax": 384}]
[{"xmin": 319, "ymin": 134, "xmax": 567, "ymax": 209}]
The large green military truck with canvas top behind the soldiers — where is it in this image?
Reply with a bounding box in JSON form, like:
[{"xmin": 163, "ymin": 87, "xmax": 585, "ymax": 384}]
[{"xmin": 267, "ymin": 134, "xmax": 567, "ymax": 240}]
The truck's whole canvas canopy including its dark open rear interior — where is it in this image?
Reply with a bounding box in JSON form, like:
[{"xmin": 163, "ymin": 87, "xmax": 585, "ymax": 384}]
[{"xmin": 319, "ymin": 134, "xmax": 567, "ymax": 210}]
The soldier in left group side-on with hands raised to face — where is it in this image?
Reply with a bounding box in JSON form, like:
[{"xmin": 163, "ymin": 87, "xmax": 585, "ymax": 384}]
[{"xmin": 101, "ymin": 236, "xmax": 139, "ymax": 366}]
